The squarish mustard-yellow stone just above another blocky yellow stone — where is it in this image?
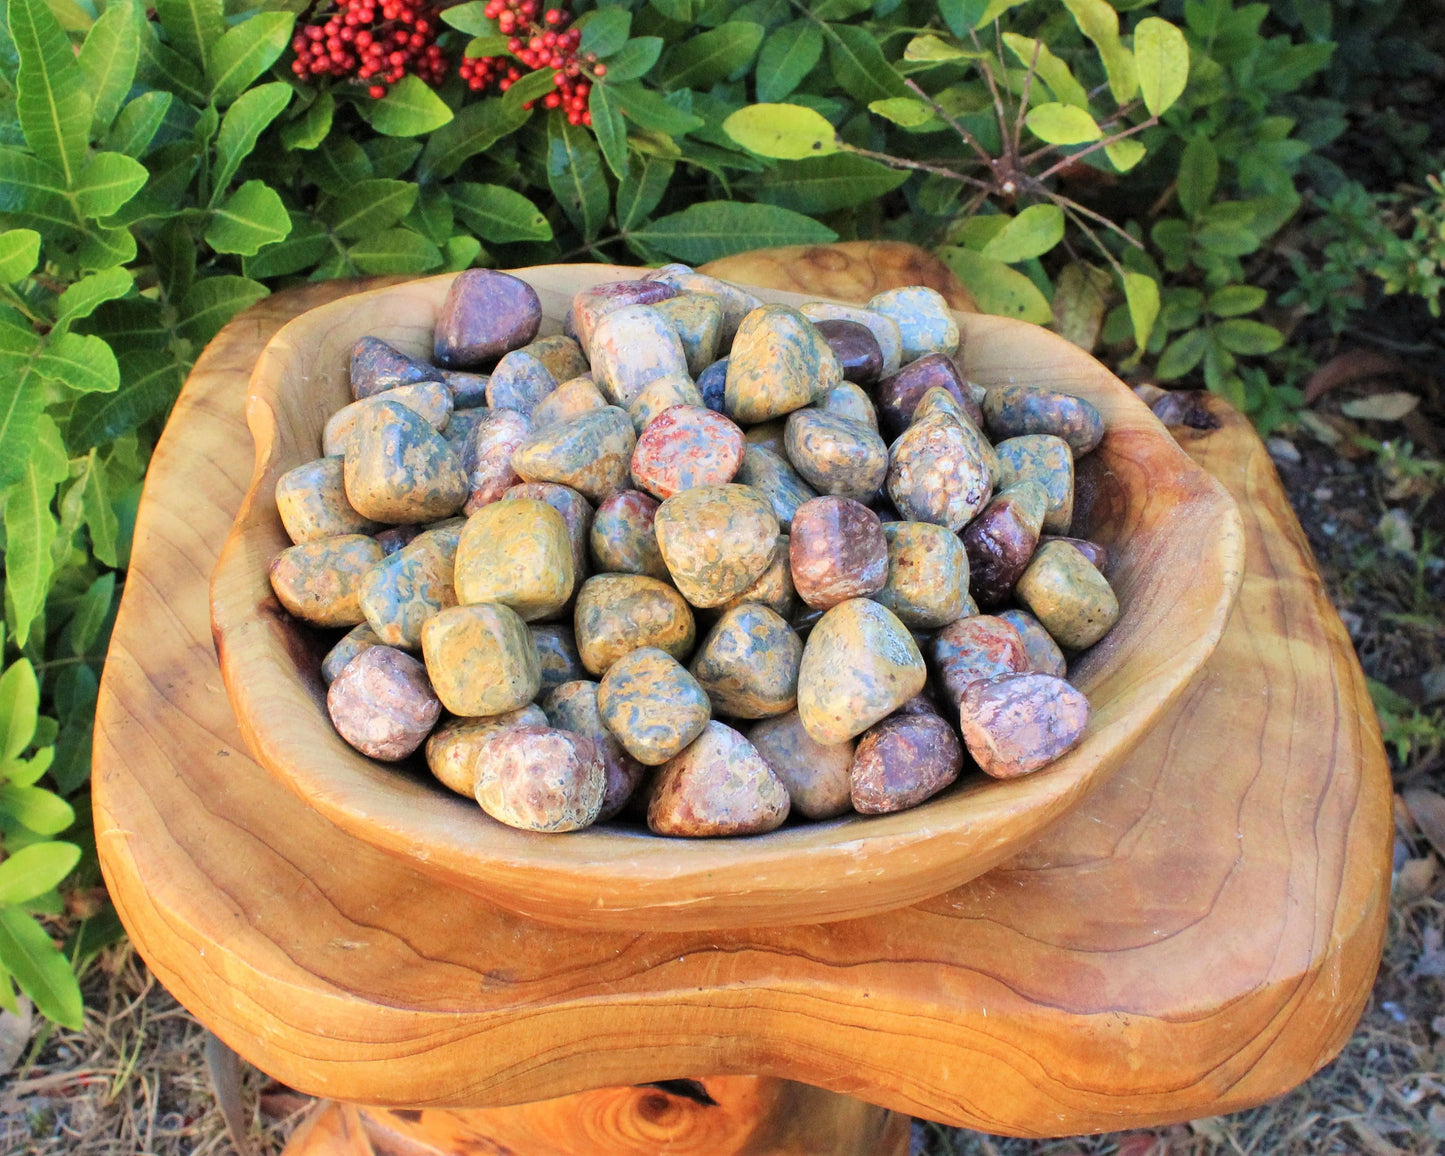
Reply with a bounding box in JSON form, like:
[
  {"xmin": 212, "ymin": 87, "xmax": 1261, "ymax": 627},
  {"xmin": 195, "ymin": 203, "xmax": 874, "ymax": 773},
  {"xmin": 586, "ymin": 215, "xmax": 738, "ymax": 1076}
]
[{"xmin": 447, "ymin": 499, "xmax": 575, "ymax": 624}]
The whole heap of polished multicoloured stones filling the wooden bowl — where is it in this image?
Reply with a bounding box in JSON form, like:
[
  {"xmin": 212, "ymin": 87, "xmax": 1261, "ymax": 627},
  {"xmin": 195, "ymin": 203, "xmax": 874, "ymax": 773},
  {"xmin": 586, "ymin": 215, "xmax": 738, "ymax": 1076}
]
[{"xmin": 270, "ymin": 264, "xmax": 1118, "ymax": 835}]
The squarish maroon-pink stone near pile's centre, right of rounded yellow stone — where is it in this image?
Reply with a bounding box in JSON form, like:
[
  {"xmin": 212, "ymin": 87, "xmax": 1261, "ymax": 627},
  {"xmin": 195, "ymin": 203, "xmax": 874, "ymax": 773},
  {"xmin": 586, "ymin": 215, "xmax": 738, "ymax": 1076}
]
[{"xmin": 788, "ymin": 494, "xmax": 889, "ymax": 610}]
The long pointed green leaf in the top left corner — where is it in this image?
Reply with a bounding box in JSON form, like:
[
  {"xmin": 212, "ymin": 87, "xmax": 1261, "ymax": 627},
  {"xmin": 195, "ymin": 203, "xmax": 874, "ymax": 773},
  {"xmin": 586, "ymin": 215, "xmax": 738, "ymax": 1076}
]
[{"xmin": 9, "ymin": 0, "xmax": 91, "ymax": 186}]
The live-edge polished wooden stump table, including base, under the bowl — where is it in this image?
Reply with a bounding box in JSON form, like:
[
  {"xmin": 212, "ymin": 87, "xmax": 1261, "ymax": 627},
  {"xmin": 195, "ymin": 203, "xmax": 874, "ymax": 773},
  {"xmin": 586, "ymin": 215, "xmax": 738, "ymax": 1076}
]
[{"xmin": 94, "ymin": 246, "xmax": 1392, "ymax": 1156}]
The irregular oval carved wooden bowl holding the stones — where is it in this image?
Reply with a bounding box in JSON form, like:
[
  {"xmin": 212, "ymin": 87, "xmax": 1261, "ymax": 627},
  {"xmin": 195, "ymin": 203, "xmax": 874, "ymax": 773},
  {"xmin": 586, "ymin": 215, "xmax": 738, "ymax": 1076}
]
[{"xmin": 209, "ymin": 264, "xmax": 1243, "ymax": 931}]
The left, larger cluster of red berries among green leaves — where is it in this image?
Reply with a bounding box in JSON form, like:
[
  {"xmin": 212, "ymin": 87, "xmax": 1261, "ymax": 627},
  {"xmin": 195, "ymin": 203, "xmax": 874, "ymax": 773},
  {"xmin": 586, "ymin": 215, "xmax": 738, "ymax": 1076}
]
[{"xmin": 290, "ymin": 0, "xmax": 447, "ymax": 100}]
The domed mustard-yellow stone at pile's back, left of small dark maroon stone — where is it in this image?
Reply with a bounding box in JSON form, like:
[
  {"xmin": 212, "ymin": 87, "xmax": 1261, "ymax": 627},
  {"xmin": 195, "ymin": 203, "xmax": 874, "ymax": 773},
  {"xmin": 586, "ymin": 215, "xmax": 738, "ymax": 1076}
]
[{"xmin": 724, "ymin": 305, "xmax": 842, "ymax": 425}]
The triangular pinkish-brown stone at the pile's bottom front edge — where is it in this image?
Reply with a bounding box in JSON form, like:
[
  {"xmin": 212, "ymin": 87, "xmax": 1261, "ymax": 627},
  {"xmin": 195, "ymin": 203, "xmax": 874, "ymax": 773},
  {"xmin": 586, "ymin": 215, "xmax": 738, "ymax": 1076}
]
[{"xmin": 647, "ymin": 723, "xmax": 790, "ymax": 837}]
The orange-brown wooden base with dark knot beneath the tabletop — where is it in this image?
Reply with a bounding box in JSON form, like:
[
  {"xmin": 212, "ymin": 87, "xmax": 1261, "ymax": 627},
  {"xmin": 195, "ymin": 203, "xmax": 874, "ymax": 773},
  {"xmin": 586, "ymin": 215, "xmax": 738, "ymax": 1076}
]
[{"xmin": 283, "ymin": 1077, "xmax": 909, "ymax": 1156}]
